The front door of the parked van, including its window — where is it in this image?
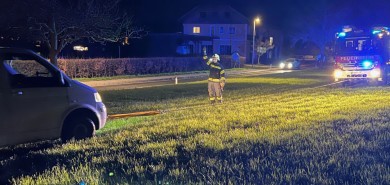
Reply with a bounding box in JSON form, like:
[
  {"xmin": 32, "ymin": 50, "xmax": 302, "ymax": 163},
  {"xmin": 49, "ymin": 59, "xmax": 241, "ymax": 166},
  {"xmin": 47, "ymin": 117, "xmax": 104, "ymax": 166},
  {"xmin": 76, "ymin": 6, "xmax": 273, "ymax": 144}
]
[{"xmin": 2, "ymin": 53, "xmax": 69, "ymax": 144}]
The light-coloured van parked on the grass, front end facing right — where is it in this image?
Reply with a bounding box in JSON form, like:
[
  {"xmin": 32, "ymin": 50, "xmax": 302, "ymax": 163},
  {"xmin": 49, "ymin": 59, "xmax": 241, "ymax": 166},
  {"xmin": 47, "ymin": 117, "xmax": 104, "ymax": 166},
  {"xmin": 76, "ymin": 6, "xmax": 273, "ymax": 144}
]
[{"xmin": 0, "ymin": 48, "xmax": 107, "ymax": 146}]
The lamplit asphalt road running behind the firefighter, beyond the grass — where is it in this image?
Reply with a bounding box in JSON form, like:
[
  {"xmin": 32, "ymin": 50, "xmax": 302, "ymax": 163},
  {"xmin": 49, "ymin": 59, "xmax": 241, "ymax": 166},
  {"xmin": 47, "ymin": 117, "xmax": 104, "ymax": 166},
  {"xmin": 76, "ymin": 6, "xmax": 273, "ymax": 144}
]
[{"xmin": 83, "ymin": 68, "xmax": 292, "ymax": 91}]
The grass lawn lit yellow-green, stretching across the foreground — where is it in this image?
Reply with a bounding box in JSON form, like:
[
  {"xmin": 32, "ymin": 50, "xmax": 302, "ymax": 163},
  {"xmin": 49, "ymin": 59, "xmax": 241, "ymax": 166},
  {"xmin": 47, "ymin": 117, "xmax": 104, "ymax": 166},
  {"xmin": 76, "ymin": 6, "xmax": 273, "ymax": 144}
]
[{"xmin": 0, "ymin": 68, "xmax": 390, "ymax": 184}]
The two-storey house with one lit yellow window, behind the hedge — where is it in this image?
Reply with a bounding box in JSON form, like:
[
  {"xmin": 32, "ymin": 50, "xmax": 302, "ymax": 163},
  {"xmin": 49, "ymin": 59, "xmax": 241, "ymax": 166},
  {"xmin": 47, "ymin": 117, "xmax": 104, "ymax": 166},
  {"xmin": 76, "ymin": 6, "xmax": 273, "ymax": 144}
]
[{"xmin": 180, "ymin": 4, "xmax": 251, "ymax": 59}]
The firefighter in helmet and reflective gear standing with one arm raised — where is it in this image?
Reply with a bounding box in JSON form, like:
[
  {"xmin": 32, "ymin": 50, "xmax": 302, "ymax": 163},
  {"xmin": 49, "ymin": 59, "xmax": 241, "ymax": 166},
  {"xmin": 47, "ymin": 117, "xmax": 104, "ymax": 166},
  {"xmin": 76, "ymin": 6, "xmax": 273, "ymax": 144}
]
[{"xmin": 203, "ymin": 54, "xmax": 226, "ymax": 104}]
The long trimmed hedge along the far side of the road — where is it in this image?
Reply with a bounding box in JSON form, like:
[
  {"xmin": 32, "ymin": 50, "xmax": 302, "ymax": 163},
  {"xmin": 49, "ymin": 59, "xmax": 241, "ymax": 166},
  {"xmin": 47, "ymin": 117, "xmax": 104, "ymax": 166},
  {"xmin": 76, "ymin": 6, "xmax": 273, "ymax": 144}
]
[{"xmin": 58, "ymin": 57, "xmax": 244, "ymax": 78}]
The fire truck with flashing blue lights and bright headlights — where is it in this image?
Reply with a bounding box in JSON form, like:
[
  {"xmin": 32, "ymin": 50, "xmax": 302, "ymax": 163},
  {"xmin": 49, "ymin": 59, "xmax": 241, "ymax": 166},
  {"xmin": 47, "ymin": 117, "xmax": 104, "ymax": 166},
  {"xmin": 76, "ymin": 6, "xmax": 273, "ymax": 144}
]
[{"xmin": 334, "ymin": 27, "xmax": 390, "ymax": 85}]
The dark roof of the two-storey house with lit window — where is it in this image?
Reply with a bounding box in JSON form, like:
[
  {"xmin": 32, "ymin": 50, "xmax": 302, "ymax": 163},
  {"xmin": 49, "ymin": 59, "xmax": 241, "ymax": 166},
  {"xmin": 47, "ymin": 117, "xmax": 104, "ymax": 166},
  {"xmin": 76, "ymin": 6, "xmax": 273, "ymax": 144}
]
[{"xmin": 179, "ymin": 4, "xmax": 249, "ymax": 24}]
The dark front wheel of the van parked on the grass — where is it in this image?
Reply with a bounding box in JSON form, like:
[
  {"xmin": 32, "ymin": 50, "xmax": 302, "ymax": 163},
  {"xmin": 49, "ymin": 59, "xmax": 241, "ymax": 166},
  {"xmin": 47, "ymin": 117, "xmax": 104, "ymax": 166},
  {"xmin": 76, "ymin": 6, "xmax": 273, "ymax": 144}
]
[{"xmin": 61, "ymin": 118, "xmax": 95, "ymax": 142}]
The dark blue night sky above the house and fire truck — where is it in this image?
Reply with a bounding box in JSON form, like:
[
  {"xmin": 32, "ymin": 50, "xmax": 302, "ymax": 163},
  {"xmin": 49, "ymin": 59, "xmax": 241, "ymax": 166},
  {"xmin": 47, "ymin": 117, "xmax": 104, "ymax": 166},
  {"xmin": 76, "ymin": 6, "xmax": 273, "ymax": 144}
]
[{"xmin": 123, "ymin": 0, "xmax": 390, "ymax": 32}]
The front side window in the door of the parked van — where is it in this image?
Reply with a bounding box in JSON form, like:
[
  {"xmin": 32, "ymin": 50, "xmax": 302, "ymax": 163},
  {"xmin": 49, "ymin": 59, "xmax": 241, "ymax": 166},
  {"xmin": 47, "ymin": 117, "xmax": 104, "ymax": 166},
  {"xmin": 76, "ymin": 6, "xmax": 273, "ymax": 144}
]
[{"xmin": 3, "ymin": 56, "xmax": 58, "ymax": 88}]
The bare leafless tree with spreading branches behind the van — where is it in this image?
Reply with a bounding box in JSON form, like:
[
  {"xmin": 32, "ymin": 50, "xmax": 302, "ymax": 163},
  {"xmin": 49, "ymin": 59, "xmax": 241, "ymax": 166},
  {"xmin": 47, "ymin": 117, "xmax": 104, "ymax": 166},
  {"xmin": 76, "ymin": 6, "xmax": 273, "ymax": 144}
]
[{"xmin": 6, "ymin": 0, "xmax": 145, "ymax": 65}]
